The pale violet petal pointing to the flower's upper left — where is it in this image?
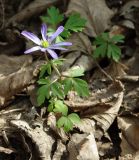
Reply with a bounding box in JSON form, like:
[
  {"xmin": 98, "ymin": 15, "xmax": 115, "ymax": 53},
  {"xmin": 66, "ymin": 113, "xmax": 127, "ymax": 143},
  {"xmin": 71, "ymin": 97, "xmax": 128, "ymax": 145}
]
[{"xmin": 21, "ymin": 31, "xmax": 41, "ymax": 45}]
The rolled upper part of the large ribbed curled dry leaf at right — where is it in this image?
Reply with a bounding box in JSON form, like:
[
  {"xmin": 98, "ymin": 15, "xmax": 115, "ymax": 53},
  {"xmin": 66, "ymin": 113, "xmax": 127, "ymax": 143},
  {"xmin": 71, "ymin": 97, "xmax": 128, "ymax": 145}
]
[{"xmin": 64, "ymin": 81, "xmax": 124, "ymax": 110}]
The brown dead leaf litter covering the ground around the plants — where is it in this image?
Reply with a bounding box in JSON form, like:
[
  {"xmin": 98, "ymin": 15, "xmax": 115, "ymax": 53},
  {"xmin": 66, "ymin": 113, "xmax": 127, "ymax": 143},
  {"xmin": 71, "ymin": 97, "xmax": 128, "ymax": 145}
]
[{"xmin": 0, "ymin": 0, "xmax": 139, "ymax": 160}]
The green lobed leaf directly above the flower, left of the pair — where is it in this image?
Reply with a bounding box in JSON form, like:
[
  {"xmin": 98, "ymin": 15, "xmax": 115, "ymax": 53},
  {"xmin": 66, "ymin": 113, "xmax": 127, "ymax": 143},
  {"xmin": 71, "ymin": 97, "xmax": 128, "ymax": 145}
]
[{"xmin": 41, "ymin": 7, "xmax": 64, "ymax": 27}]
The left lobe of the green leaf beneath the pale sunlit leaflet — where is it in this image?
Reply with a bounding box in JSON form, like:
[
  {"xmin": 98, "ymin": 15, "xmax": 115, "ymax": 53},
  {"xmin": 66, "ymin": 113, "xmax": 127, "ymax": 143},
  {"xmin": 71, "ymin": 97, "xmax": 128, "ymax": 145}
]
[{"xmin": 63, "ymin": 78, "xmax": 72, "ymax": 95}]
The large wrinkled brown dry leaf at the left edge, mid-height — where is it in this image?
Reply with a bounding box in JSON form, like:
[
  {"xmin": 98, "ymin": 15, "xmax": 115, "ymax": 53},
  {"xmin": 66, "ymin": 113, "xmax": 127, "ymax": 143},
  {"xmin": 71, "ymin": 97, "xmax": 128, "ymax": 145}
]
[{"xmin": 0, "ymin": 55, "xmax": 34, "ymax": 106}]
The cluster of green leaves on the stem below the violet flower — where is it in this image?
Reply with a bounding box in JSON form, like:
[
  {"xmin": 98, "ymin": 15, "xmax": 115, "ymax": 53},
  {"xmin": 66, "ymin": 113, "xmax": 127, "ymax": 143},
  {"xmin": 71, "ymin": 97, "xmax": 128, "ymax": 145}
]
[{"xmin": 37, "ymin": 59, "xmax": 89, "ymax": 132}]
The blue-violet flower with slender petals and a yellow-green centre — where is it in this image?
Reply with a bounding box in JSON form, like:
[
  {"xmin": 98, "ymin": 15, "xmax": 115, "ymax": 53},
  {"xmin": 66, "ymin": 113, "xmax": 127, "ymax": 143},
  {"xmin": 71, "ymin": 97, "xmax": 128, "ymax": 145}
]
[{"xmin": 21, "ymin": 24, "xmax": 72, "ymax": 59}]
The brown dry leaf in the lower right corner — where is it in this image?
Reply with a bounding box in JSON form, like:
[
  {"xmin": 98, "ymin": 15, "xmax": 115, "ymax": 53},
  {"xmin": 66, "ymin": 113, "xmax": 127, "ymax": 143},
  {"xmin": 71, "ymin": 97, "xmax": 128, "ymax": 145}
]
[{"xmin": 118, "ymin": 115, "xmax": 139, "ymax": 157}]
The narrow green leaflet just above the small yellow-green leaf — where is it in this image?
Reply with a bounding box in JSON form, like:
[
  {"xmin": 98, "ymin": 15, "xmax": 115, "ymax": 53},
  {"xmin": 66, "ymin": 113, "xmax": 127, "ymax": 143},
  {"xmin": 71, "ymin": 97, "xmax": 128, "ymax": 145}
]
[{"xmin": 51, "ymin": 82, "xmax": 65, "ymax": 99}]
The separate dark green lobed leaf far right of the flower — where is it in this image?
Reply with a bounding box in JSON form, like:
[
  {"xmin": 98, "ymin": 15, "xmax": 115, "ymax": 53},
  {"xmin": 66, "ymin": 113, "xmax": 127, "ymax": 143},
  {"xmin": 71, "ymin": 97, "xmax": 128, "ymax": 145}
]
[{"xmin": 93, "ymin": 33, "xmax": 124, "ymax": 62}]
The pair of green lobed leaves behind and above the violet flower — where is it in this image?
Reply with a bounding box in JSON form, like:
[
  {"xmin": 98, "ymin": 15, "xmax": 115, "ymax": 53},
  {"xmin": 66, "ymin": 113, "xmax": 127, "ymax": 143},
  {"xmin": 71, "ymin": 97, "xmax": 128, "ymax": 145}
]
[{"xmin": 40, "ymin": 7, "xmax": 86, "ymax": 41}]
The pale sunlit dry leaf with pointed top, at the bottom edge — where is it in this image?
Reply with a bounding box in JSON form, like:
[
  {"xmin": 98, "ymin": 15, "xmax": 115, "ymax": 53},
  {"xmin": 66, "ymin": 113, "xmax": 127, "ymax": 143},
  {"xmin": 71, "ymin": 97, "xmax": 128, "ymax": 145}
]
[{"xmin": 68, "ymin": 133, "xmax": 99, "ymax": 160}]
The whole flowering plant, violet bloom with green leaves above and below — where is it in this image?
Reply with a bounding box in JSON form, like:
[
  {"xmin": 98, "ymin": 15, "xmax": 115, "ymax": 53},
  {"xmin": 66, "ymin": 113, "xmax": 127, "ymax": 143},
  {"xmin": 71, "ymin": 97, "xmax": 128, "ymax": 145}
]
[{"xmin": 21, "ymin": 7, "xmax": 89, "ymax": 132}]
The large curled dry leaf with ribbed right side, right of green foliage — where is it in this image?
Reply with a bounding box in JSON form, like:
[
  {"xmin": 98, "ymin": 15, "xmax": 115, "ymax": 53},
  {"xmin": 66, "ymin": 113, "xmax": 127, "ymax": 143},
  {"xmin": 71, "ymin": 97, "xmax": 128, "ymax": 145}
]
[{"xmin": 65, "ymin": 81, "xmax": 124, "ymax": 138}]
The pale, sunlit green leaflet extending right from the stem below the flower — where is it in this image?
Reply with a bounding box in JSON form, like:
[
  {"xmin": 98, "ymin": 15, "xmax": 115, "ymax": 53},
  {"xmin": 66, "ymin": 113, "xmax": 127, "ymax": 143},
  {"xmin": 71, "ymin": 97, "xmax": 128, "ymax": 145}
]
[{"xmin": 67, "ymin": 66, "xmax": 84, "ymax": 77}]
